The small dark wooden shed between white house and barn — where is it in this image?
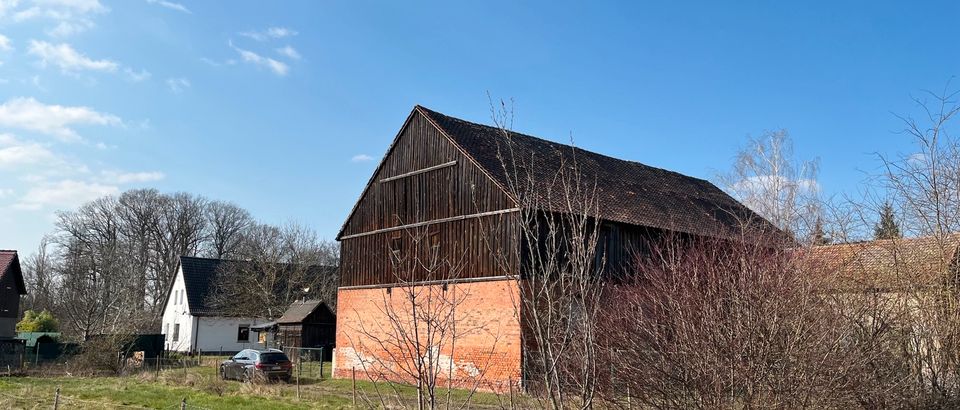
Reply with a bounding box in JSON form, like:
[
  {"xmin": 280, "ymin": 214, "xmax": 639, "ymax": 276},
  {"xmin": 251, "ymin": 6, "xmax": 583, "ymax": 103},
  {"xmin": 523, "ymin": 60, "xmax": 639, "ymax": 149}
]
[{"xmin": 276, "ymin": 300, "xmax": 337, "ymax": 349}]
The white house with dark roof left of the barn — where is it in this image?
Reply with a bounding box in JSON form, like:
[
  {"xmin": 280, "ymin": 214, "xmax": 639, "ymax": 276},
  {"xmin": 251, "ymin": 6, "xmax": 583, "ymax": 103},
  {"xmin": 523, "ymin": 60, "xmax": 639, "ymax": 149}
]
[{"xmin": 161, "ymin": 256, "xmax": 271, "ymax": 353}]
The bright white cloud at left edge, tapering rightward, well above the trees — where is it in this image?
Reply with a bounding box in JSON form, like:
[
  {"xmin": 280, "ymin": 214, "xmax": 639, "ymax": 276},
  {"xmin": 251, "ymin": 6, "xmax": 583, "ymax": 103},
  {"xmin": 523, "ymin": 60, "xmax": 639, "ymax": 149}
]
[{"xmin": 0, "ymin": 97, "xmax": 123, "ymax": 141}]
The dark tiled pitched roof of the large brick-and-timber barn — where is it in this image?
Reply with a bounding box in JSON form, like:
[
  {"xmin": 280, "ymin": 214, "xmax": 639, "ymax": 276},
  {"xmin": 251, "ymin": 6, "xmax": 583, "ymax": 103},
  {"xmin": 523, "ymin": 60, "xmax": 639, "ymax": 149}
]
[{"xmin": 415, "ymin": 105, "xmax": 782, "ymax": 237}]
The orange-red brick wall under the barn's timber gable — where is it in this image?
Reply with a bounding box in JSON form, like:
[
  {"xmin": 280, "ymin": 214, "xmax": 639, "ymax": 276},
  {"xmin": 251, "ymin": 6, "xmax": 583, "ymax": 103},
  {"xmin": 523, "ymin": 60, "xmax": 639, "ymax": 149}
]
[{"xmin": 333, "ymin": 280, "xmax": 521, "ymax": 391}]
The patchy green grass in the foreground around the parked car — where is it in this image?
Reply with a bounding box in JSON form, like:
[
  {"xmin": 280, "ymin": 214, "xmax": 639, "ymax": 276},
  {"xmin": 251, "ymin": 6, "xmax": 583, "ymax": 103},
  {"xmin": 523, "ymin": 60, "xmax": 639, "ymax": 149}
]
[{"xmin": 0, "ymin": 359, "xmax": 516, "ymax": 410}]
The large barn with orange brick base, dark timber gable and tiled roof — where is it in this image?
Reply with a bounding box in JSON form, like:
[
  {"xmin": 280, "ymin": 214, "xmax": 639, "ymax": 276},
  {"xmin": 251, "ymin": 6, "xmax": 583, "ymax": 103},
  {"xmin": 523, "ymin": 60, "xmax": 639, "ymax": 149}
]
[{"xmin": 334, "ymin": 106, "xmax": 771, "ymax": 385}]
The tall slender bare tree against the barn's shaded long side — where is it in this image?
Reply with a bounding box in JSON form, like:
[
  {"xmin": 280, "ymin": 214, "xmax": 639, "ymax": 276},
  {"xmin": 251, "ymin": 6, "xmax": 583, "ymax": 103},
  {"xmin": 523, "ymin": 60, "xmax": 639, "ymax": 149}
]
[{"xmin": 487, "ymin": 101, "xmax": 605, "ymax": 409}]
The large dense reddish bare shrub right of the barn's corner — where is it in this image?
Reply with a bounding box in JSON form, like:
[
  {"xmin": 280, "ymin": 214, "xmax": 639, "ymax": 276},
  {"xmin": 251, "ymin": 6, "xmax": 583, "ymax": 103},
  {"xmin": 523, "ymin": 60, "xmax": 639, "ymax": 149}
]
[{"xmin": 603, "ymin": 239, "xmax": 873, "ymax": 408}]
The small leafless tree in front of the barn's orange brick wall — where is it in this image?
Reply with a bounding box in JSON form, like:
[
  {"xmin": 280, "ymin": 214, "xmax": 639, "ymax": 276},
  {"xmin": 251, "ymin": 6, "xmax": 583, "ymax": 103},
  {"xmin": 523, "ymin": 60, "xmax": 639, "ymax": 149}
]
[{"xmin": 349, "ymin": 227, "xmax": 500, "ymax": 409}]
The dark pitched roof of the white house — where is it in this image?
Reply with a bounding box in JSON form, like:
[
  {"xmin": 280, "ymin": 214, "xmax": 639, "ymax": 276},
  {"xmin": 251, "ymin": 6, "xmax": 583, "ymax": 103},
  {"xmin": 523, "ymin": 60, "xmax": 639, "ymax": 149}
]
[{"xmin": 174, "ymin": 256, "xmax": 336, "ymax": 316}]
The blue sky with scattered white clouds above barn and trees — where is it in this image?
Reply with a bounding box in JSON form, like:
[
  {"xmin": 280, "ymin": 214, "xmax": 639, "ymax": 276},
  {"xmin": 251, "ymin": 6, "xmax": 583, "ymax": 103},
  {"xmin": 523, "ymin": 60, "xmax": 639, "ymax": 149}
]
[{"xmin": 0, "ymin": 0, "xmax": 960, "ymax": 253}]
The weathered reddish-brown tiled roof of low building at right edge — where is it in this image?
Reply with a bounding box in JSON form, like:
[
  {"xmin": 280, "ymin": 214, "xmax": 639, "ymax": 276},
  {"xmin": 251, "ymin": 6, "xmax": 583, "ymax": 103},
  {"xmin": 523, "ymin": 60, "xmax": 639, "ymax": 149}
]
[{"xmin": 802, "ymin": 234, "xmax": 960, "ymax": 292}]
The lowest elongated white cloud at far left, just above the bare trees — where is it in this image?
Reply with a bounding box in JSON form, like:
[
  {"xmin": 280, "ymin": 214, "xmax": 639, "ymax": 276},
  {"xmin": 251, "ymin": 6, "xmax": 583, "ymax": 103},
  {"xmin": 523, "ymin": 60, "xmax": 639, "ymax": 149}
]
[{"xmin": 13, "ymin": 179, "xmax": 120, "ymax": 210}]
